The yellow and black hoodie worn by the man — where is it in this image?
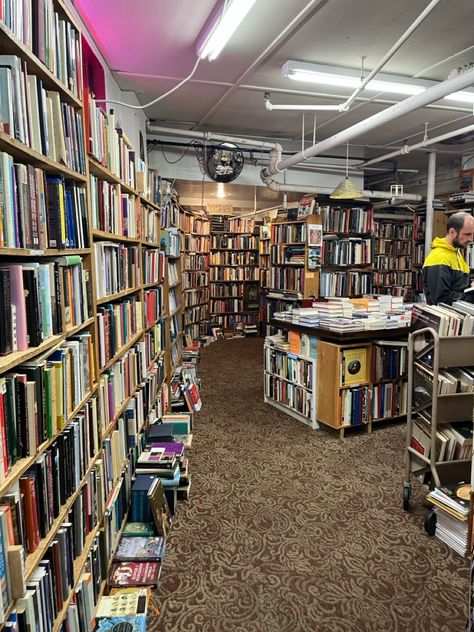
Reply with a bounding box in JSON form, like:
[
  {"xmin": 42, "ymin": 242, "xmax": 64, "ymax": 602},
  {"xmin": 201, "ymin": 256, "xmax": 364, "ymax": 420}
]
[{"xmin": 423, "ymin": 237, "xmax": 470, "ymax": 305}]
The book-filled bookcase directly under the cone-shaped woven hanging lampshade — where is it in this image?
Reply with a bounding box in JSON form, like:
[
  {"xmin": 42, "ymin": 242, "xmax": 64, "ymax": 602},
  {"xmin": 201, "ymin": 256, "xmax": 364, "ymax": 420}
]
[{"xmin": 319, "ymin": 203, "xmax": 374, "ymax": 298}]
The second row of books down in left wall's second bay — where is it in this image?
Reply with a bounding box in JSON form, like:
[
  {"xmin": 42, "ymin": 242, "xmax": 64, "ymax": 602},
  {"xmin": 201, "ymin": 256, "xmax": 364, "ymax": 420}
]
[{"xmin": 89, "ymin": 174, "xmax": 140, "ymax": 238}]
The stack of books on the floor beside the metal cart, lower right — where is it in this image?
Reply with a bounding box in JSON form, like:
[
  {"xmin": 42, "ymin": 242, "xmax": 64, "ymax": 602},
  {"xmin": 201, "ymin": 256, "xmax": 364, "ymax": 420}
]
[{"xmin": 427, "ymin": 482, "xmax": 471, "ymax": 557}]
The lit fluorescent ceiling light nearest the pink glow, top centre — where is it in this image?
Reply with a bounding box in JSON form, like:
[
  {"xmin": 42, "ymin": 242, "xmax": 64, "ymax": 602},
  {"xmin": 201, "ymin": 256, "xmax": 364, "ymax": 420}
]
[{"xmin": 197, "ymin": 0, "xmax": 256, "ymax": 61}]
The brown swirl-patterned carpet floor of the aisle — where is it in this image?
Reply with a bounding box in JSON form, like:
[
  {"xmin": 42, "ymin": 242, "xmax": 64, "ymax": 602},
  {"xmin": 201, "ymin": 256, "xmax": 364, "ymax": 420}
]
[{"xmin": 148, "ymin": 339, "xmax": 468, "ymax": 632}]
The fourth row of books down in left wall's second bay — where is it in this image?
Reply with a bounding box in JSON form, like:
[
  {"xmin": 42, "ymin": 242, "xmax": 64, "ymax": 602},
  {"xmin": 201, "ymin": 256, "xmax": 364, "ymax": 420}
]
[{"xmin": 97, "ymin": 296, "xmax": 141, "ymax": 367}]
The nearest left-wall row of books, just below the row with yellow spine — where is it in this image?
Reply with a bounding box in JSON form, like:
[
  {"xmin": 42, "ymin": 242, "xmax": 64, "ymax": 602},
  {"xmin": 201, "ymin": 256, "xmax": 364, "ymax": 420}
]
[{"xmin": 0, "ymin": 255, "xmax": 92, "ymax": 355}]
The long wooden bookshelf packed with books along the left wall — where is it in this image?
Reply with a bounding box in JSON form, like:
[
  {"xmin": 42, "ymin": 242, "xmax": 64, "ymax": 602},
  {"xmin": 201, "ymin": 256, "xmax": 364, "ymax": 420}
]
[{"xmin": 0, "ymin": 7, "xmax": 170, "ymax": 630}]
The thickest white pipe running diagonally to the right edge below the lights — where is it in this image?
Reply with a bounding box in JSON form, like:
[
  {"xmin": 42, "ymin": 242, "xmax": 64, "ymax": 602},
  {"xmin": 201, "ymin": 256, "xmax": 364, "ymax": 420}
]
[{"xmin": 261, "ymin": 70, "xmax": 474, "ymax": 182}]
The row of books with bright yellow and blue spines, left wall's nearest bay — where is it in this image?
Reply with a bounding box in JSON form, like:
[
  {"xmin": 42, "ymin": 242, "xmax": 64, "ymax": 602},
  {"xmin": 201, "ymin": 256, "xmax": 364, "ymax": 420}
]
[{"xmin": 0, "ymin": 158, "xmax": 89, "ymax": 250}]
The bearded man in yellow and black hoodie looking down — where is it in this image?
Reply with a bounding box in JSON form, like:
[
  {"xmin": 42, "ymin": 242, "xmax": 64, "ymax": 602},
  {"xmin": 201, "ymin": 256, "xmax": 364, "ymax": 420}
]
[{"xmin": 423, "ymin": 211, "xmax": 474, "ymax": 305}]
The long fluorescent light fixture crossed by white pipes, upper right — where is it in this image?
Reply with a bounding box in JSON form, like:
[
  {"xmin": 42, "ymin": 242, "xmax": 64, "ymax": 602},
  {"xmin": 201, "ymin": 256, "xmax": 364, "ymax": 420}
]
[{"xmin": 282, "ymin": 61, "xmax": 474, "ymax": 103}]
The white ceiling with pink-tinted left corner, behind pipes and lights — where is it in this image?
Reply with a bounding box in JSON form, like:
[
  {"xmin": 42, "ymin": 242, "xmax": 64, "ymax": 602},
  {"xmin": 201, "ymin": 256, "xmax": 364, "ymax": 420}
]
[{"xmin": 74, "ymin": 0, "xmax": 474, "ymax": 183}]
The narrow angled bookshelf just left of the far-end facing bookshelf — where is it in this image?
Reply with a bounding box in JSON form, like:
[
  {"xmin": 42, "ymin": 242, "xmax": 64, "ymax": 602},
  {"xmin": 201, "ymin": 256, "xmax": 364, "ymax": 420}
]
[{"xmin": 181, "ymin": 210, "xmax": 211, "ymax": 345}]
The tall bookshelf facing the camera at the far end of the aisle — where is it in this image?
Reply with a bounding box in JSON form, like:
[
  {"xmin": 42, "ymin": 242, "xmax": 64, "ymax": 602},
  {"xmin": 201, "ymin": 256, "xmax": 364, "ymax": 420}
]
[{"xmin": 209, "ymin": 215, "xmax": 259, "ymax": 329}]
